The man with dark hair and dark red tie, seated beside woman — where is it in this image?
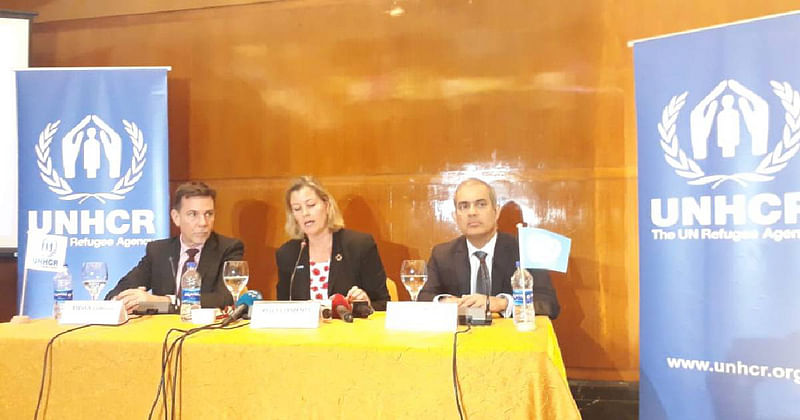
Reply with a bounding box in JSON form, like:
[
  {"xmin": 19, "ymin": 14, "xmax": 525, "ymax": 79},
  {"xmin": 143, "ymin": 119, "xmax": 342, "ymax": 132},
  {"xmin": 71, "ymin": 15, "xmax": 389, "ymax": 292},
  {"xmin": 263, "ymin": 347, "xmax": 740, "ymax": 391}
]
[{"xmin": 106, "ymin": 182, "xmax": 244, "ymax": 313}]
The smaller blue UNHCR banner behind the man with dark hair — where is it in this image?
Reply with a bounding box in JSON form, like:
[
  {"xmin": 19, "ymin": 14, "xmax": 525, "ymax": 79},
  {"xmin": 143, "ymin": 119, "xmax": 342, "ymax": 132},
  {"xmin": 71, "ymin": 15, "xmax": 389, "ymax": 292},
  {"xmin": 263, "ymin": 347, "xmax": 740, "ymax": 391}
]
[{"xmin": 17, "ymin": 68, "xmax": 169, "ymax": 317}]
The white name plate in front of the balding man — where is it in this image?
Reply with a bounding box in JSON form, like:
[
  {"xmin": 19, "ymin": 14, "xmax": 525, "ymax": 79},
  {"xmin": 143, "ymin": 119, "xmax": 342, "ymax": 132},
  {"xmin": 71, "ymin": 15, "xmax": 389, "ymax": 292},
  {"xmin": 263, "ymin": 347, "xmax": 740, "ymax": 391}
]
[{"xmin": 386, "ymin": 302, "xmax": 458, "ymax": 332}]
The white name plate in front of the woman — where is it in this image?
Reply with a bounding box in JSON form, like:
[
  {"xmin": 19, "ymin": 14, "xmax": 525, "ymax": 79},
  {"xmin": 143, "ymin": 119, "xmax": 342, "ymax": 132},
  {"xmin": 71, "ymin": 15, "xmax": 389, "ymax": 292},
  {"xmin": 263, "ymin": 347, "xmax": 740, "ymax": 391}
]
[{"xmin": 250, "ymin": 300, "xmax": 320, "ymax": 328}]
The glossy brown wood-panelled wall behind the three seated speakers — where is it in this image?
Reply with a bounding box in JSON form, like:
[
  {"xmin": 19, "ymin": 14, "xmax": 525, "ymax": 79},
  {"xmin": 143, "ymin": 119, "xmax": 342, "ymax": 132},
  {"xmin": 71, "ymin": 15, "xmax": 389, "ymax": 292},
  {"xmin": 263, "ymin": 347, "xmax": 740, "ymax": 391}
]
[{"xmin": 6, "ymin": 0, "xmax": 796, "ymax": 380}]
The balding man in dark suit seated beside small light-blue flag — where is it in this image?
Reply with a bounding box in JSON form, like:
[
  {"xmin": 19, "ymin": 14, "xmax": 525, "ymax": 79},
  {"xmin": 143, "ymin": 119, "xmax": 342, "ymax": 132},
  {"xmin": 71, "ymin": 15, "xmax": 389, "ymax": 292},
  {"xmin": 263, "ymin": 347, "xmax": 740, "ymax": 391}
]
[{"xmin": 418, "ymin": 178, "xmax": 561, "ymax": 319}]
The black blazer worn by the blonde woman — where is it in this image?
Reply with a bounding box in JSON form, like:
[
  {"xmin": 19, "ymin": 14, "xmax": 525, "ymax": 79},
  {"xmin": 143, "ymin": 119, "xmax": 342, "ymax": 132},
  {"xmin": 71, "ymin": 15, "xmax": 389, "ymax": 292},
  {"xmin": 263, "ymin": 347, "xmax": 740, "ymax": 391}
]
[{"xmin": 275, "ymin": 229, "xmax": 389, "ymax": 311}]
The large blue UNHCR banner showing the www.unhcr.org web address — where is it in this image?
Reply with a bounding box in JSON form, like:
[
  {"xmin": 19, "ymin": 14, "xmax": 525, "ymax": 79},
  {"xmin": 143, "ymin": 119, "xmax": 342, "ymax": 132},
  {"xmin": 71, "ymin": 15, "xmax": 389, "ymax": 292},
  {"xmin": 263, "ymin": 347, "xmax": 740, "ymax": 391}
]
[{"xmin": 634, "ymin": 14, "xmax": 800, "ymax": 420}]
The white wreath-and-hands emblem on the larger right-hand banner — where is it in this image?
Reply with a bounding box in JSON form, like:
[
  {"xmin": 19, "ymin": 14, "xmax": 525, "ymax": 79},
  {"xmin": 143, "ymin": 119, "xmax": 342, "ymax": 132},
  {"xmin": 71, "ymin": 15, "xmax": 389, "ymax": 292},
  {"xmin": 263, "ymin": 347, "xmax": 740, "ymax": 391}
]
[{"xmin": 658, "ymin": 79, "xmax": 800, "ymax": 189}]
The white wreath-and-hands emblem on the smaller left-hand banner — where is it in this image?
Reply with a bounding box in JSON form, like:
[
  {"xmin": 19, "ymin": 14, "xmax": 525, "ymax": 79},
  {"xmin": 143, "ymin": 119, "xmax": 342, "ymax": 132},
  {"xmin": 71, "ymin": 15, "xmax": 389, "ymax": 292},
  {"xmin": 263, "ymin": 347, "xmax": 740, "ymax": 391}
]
[{"xmin": 34, "ymin": 115, "xmax": 147, "ymax": 204}]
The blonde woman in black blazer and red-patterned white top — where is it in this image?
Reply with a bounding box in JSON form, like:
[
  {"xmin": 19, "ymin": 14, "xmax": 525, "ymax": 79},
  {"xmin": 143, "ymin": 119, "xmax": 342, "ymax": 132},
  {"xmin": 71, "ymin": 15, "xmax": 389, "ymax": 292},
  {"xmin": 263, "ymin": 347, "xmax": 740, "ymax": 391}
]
[{"xmin": 275, "ymin": 176, "xmax": 389, "ymax": 311}]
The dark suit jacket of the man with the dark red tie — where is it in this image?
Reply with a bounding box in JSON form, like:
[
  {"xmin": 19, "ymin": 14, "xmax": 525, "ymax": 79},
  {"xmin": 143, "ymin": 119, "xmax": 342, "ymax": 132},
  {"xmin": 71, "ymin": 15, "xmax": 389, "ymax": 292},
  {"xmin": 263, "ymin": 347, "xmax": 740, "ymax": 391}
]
[{"xmin": 106, "ymin": 232, "xmax": 244, "ymax": 308}]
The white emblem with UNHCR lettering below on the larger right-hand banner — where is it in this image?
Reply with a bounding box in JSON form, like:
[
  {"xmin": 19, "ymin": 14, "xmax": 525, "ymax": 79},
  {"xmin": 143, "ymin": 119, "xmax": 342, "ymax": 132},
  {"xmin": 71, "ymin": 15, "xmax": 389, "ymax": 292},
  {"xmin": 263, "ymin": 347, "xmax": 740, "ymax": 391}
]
[{"xmin": 650, "ymin": 79, "xmax": 800, "ymax": 241}]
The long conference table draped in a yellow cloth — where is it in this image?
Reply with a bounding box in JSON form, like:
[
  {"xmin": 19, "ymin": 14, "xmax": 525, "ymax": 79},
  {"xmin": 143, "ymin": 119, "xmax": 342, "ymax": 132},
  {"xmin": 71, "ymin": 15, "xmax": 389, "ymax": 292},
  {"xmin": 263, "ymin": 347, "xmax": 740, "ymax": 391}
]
[{"xmin": 0, "ymin": 312, "xmax": 580, "ymax": 420}]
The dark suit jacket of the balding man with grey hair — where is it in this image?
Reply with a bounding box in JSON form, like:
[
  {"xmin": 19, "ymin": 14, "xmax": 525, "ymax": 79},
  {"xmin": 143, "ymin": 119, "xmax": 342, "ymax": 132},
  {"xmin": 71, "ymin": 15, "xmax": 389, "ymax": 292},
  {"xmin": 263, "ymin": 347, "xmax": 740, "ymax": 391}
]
[{"xmin": 418, "ymin": 232, "xmax": 561, "ymax": 319}]
